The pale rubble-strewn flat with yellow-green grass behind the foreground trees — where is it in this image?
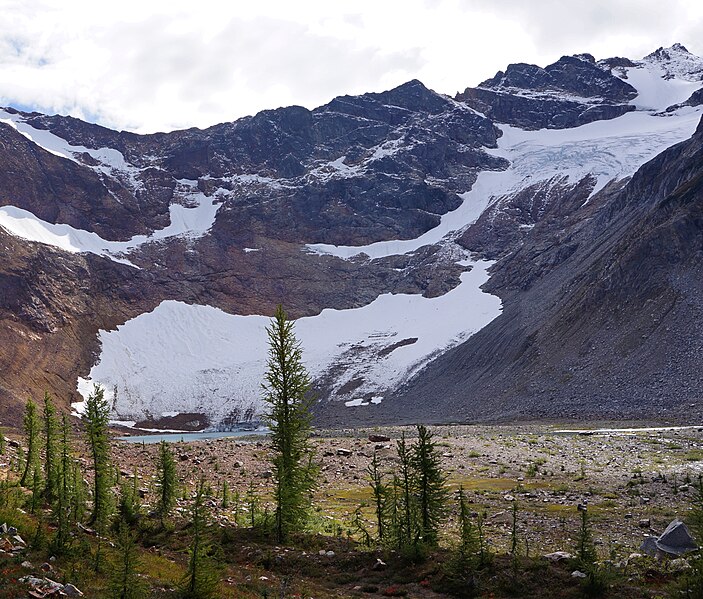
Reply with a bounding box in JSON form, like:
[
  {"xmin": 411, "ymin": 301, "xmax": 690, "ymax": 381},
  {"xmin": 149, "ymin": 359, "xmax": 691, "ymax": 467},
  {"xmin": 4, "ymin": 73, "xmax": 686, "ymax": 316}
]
[{"xmin": 113, "ymin": 425, "xmax": 703, "ymax": 556}]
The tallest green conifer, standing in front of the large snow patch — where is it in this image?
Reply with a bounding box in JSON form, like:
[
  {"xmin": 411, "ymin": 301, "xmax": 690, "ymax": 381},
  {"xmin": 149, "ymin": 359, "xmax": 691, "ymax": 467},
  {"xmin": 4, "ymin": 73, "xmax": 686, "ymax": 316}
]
[{"xmin": 263, "ymin": 306, "xmax": 317, "ymax": 542}]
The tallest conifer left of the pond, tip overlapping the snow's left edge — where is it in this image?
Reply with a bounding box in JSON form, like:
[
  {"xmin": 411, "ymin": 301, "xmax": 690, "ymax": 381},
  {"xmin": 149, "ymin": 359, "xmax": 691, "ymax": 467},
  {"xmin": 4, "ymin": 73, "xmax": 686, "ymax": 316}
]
[{"xmin": 84, "ymin": 385, "xmax": 112, "ymax": 526}]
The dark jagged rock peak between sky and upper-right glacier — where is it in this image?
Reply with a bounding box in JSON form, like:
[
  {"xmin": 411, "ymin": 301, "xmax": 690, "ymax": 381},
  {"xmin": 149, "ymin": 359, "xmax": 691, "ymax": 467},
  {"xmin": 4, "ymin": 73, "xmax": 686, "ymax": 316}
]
[{"xmin": 456, "ymin": 54, "xmax": 637, "ymax": 129}]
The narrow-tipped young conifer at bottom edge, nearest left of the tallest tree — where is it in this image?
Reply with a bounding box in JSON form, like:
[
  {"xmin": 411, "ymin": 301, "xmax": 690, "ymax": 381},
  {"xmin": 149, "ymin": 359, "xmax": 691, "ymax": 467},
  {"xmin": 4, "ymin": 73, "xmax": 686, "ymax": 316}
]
[{"xmin": 180, "ymin": 478, "xmax": 220, "ymax": 599}]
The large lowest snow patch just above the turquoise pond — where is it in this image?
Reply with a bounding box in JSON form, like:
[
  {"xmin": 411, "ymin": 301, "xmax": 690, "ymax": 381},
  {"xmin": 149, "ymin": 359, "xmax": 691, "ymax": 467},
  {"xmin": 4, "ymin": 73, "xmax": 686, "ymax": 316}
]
[{"xmin": 78, "ymin": 261, "xmax": 502, "ymax": 421}]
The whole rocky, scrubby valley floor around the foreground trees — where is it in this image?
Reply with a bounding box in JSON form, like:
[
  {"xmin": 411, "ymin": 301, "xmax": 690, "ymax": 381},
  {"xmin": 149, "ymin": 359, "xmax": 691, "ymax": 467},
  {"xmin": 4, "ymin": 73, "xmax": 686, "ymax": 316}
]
[{"xmin": 0, "ymin": 424, "xmax": 703, "ymax": 599}]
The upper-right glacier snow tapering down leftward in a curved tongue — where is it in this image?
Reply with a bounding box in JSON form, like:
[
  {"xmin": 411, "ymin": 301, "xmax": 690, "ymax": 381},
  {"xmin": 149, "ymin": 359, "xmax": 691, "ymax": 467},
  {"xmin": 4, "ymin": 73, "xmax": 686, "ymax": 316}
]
[{"xmin": 307, "ymin": 107, "xmax": 703, "ymax": 259}]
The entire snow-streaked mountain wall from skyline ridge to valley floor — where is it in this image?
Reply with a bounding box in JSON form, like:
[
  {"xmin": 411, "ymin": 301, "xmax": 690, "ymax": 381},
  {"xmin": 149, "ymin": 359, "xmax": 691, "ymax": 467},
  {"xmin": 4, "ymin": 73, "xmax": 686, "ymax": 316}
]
[{"xmin": 0, "ymin": 46, "xmax": 703, "ymax": 425}]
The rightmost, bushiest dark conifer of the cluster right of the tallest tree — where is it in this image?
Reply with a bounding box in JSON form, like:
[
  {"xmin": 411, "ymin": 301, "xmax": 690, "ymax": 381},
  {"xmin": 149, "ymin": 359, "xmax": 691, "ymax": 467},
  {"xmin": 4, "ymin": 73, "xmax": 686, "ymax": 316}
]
[{"xmin": 412, "ymin": 425, "xmax": 449, "ymax": 547}]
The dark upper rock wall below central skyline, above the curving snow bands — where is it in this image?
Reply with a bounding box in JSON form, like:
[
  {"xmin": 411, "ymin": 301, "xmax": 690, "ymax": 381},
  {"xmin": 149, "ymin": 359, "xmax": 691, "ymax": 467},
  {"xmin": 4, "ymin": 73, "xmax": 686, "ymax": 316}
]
[{"xmin": 6, "ymin": 81, "xmax": 507, "ymax": 244}]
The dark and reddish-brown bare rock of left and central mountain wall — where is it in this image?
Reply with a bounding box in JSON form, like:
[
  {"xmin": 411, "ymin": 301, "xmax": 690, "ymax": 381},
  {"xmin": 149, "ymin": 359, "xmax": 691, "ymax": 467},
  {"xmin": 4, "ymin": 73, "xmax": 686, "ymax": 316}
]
[{"xmin": 0, "ymin": 81, "xmax": 507, "ymax": 422}]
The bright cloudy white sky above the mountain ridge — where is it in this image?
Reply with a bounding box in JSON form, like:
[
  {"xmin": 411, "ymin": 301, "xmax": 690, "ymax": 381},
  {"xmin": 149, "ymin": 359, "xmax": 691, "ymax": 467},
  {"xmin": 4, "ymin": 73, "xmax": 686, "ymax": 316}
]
[{"xmin": 0, "ymin": 0, "xmax": 703, "ymax": 133}]
